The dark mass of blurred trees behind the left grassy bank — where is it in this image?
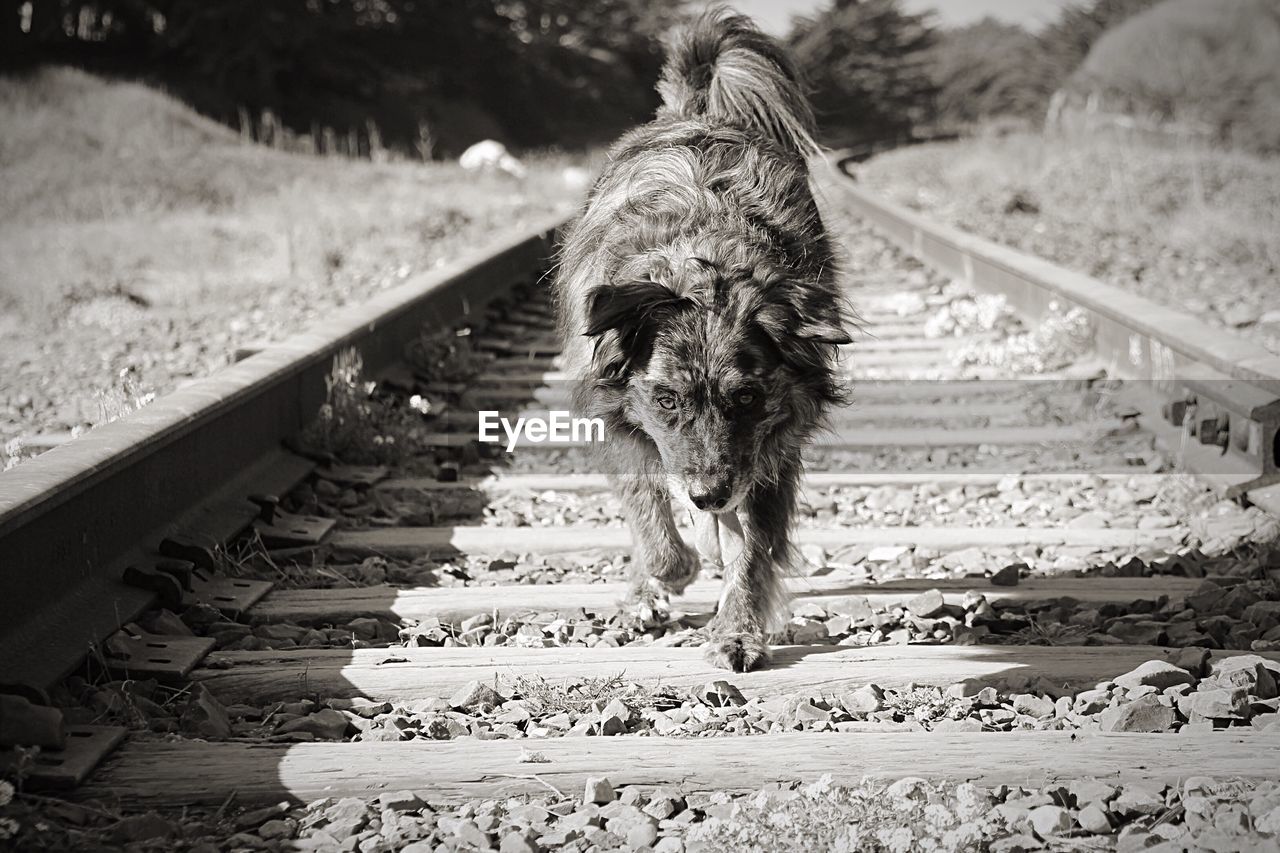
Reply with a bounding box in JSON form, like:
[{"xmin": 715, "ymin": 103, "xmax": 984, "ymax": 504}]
[{"xmin": 0, "ymin": 0, "xmax": 684, "ymax": 155}]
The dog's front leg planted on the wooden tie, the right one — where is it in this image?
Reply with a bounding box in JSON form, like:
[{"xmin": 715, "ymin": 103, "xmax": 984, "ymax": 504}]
[{"xmin": 703, "ymin": 455, "xmax": 799, "ymax": 672}]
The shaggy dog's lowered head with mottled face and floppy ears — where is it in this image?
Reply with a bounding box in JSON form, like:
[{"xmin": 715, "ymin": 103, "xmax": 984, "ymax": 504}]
[{"xmin": 586, "ymin": 256, "xmax": 850, "ymax": 512}]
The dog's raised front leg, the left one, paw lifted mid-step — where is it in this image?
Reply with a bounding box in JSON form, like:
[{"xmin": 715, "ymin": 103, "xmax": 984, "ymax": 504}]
[{"xmin": 607, "ymin": 437, "xmax": 699, "ymax": 620}]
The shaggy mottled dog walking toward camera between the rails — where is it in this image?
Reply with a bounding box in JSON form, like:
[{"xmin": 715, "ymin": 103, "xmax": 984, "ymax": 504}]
[{"xmin": 556, "ymin": 9, "xmax": 850, "ymax": 672}]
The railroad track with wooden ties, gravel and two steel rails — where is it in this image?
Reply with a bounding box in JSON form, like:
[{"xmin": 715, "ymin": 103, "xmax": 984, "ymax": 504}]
[{"xmin": 0, "ymin": 169, "xmax": 1280, "ymax": 852}]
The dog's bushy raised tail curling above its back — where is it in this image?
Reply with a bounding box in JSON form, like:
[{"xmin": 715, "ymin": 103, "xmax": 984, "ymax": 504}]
[{"xmin": 658, "ymin": 8, "xmax": 819, "ymax": 156}]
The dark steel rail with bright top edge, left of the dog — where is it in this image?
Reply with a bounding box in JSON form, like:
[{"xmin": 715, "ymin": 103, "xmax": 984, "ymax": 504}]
[{"xmin": 0, "ymin": 216, "xmax": 564, "ymax": 690}]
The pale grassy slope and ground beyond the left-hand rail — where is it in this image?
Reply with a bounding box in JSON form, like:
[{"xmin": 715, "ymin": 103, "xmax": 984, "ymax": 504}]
[{"xmin": 0, "ymin": 68, "xmax": 585, "ymax": 461}]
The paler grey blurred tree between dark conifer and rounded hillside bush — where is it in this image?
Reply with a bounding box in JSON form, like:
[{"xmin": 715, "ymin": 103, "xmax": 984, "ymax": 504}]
[{"xmin": 929, "ymin": 18, "xmax": 1046, "ymax": 126}]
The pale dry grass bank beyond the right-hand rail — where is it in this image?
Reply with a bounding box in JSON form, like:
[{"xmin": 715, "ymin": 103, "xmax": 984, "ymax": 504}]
[{"xmin": 859, "ymin": 126, "xmax": 1280, "ymax": 351}]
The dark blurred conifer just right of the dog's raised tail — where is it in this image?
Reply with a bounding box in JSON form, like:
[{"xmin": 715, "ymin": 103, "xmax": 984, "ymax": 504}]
[{"xmin": 790, "ymin": 0, "xmax": 937, "ymax": 145}]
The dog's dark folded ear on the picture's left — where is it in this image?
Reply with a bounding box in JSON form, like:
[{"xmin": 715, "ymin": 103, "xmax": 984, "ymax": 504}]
[{"xmin": 585, "ymin": 280, "xmax": 692, "ymax": 378}]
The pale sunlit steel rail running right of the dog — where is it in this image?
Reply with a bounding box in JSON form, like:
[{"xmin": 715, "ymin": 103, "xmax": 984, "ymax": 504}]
[{"xmin": 832, "ymin": 152, "xmax": 1280, "ymax": 494}]
